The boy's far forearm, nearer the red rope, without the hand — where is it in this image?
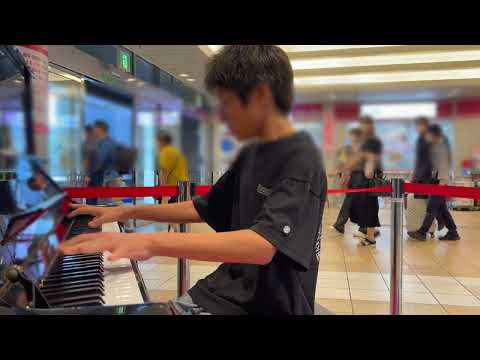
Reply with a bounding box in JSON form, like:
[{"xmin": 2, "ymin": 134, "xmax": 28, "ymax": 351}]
[{"xmin": 125, "ymin": 200, "xmax": 203, "ymax": 224}]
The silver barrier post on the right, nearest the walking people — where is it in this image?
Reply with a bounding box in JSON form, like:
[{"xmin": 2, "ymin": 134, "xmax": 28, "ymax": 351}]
[{"xmin": 390, "ymin": 178, "xmax": 405, "ymax": 315}]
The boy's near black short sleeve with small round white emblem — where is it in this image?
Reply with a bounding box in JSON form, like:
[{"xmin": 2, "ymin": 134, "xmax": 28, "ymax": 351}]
[{"xmin": 251, "ymin": 178, "xmax": 325, "ymax": 271}]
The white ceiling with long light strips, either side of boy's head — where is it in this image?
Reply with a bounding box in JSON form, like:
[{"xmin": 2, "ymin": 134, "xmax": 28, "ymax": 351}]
[{"xmin": 125, "ymin": 45, "xmax": 480, "ymax": 102}]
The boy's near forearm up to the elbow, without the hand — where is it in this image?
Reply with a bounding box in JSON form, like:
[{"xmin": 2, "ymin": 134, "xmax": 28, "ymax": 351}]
[{"xmin": 142, "ymin": 230, "xmax": 276, "ymax": 265}]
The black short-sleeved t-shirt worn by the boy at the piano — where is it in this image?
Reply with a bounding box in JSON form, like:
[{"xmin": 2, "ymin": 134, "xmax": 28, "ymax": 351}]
[{"xmin": 189, "ymin": 132, "xmax": 327, "ymax": 315}]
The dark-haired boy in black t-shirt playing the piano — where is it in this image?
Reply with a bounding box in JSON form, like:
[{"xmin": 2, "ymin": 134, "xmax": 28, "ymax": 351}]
[{"xmin": 61, "ymin": 45, "xmax": 327, "ymax": 315}]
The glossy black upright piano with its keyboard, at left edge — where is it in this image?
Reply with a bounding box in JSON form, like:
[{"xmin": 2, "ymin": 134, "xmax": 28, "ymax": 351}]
[{"xmin": 0, "ymin": 45, "xmax": 171, "ymax": 314}]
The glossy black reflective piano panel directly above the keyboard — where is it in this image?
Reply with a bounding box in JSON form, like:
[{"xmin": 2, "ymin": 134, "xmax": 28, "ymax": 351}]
[{"xmin": 0, "ymin": 157, "xmax": 66, "ymax": 290}]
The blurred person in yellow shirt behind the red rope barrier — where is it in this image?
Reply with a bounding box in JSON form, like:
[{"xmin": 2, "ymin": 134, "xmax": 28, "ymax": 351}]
[{"xmin": 157, "ymin": 131, "xmax": 189, "ymax": 231}]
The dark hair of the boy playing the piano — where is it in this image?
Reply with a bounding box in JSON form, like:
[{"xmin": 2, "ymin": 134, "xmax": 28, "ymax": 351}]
[{"xmin": 205, "ymin": 45, "xmax": 293, "ymax": 114}]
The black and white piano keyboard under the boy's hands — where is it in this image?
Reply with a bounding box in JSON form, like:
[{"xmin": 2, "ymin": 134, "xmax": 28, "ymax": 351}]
[{"xmin": 40, "ymin": 216, "xmax": 145, "ymax": 307}]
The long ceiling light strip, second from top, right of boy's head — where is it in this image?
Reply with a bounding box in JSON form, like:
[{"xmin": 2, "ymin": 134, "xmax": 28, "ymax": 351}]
[{"xmin": 291, "ymin": 50, "xmax": 480, "ymax": 70}]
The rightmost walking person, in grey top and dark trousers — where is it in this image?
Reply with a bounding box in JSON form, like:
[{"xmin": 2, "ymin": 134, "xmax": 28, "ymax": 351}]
[{"xmin": 408, "ymin": 124, "xmax": 460, "ymax": 241}]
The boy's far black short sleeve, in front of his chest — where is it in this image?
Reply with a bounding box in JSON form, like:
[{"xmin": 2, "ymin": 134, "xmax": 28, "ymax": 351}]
[{"xmin": 193, "ymin": 170, "xmax": 235, "ymax": 231}]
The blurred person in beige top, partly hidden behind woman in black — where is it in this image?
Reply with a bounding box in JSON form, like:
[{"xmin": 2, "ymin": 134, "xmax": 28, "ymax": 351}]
[{"xmin": 333, "ymin": 128, "xmax": 362, "ymax": 234}]
